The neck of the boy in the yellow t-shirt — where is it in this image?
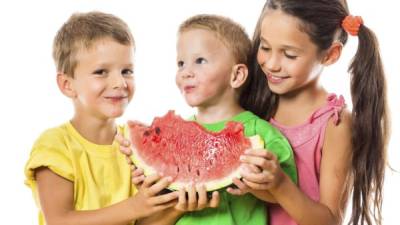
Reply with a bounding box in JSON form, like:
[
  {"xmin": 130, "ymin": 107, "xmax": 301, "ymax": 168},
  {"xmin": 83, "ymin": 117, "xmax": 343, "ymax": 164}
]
[{"xmin": 71, "ymin": 113, "xmax": 117, "ymax": 145}]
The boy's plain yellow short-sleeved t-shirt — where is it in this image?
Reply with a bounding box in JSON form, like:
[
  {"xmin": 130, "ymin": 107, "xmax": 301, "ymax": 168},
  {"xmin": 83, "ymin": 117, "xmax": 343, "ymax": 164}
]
[{"xmin": 25, "ymin": 122, "xmax": 136, "ymax": 225}]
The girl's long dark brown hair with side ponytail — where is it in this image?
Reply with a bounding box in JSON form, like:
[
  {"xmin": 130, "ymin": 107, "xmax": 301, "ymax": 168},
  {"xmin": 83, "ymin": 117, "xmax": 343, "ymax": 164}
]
[{"xmin": 240, "ymin": 0, "xmax": 389, "ymax": 225}]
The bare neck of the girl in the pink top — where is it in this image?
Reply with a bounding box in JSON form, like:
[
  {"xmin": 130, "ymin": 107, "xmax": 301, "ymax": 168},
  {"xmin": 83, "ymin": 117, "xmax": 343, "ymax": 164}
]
[{"xmin": 274, "ymin": 81, "xmax": 328, "ymax": 126}]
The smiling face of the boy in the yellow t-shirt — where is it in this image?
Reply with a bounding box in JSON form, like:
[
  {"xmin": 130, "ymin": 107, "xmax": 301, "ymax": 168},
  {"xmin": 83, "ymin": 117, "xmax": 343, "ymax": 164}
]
[{"xmin": 65, "ymin": 38, "xmax": 134, "ymax": 119}]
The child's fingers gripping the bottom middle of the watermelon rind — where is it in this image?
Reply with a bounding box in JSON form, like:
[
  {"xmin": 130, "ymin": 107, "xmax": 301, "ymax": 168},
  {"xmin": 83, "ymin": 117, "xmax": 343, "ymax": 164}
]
[{"xmin": 175, "ymin": 185, "xmax": 219, "ymax": 212}]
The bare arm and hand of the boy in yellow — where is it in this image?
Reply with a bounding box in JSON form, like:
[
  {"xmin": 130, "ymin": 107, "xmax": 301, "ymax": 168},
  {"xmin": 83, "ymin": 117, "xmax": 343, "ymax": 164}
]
[{"xmin": 36, "ymin": 167, "xmax": 178, "ymax": 225}]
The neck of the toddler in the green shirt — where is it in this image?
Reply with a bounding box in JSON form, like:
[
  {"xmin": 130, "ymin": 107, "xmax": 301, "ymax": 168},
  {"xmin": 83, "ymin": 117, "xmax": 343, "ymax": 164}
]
[{"xmin": 196, "ymin": 102, "xmax": 244, "ymax": 123}]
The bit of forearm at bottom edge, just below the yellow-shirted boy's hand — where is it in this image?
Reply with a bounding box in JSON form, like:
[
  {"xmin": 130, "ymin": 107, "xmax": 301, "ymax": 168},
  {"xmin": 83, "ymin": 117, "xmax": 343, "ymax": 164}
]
[{"xmin": 135, "ymin": 208, "xmax": 184, "ymax": 225}]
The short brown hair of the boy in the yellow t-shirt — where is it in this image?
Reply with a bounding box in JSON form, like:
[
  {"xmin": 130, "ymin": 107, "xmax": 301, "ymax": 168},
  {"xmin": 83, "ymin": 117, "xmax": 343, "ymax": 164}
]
[{"xmin": 53, "ymin": 12, "xmax": 135, "ymax": 77}]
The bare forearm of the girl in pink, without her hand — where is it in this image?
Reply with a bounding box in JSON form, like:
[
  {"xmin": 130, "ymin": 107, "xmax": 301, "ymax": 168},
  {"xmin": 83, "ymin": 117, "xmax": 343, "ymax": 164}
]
[{"xmin": 270, "ymin": 176, "xmax": 341, "ymax": 225}]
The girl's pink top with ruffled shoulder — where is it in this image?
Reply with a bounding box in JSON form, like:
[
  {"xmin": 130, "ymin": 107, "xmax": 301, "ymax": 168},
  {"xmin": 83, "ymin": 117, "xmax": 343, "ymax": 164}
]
[{"xmin": 268, "ymin": 94, "xmax": 345, "ymax": 225}]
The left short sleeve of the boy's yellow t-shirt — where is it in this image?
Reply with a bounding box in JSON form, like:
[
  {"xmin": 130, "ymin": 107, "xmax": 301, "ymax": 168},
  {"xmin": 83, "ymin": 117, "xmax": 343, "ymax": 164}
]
[{"xmin": 24, "ymin": 128, "xmax": 74, "ymax": 187}]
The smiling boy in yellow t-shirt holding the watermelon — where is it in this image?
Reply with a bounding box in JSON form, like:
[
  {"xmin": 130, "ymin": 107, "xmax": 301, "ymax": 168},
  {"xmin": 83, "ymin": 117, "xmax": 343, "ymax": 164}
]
[{"xmin": 25, "ymin": 12, "xmax": 178, "ymax": 225}]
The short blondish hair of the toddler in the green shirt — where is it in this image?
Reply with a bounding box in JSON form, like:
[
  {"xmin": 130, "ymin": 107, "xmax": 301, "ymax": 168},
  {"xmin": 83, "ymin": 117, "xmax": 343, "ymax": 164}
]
[{"xmin": 179, "ymin": 14, "xmax": 251, "ymax": 65}]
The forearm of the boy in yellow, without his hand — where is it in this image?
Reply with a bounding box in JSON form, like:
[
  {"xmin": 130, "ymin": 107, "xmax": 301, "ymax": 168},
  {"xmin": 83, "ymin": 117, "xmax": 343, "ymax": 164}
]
[{"xmin": 45, "ymin": 199, "xmax": 137, "ymax": 225}]
